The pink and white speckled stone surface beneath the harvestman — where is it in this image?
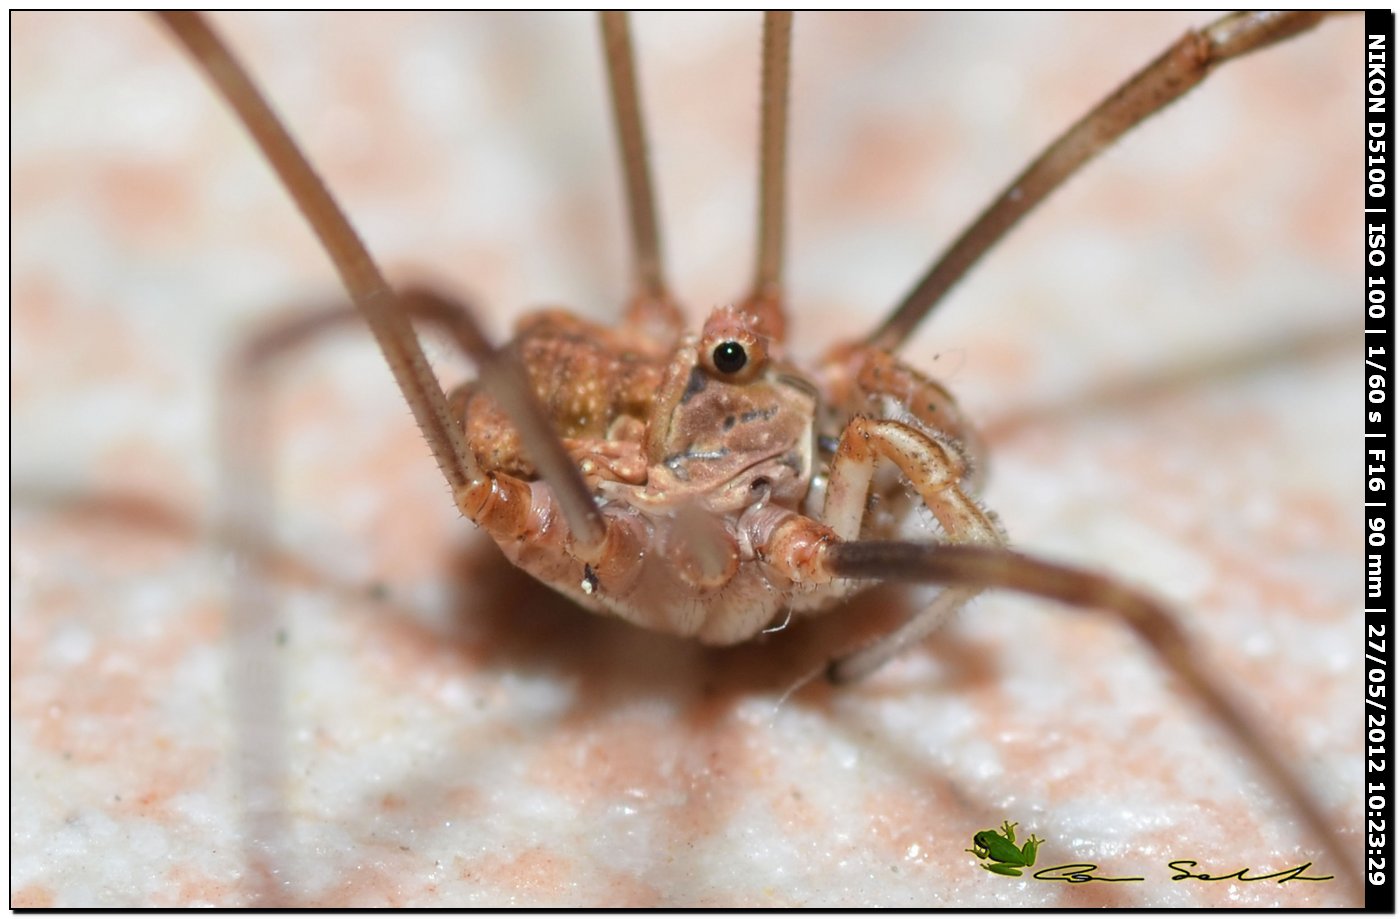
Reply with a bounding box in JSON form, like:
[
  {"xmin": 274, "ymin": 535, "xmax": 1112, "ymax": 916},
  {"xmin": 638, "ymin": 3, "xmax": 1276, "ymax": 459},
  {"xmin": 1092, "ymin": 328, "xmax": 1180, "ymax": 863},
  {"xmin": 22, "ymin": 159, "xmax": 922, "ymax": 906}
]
[{"xmin": 10, "ymin": 14, "xmax": 1362, "ymax": 906}]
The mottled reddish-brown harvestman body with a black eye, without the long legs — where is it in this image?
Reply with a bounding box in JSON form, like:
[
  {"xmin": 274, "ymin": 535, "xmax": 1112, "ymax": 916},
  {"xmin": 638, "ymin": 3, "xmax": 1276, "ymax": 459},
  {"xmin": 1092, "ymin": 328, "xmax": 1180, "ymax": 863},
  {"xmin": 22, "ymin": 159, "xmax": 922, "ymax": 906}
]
[{"xmin": 454, "ymin": 308, "xmax": 980, "ymax": 644}]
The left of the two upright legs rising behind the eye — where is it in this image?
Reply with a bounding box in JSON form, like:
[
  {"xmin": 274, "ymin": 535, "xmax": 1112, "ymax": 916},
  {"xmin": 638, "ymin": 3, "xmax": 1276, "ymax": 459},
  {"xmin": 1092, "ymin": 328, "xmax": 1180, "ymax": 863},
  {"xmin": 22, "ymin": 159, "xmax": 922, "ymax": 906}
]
[{"xmin": 598, "ymin": 11, "xmax": 683, "ymax": 343}]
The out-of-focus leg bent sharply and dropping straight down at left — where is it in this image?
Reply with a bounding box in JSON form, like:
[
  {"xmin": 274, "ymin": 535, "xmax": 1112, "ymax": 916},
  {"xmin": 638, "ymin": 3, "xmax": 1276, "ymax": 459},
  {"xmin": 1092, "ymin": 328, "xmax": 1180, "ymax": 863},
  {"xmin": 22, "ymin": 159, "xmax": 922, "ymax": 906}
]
[{"xmin": 217, "ymin": 289, "xmax": 606, "ymax": 906}]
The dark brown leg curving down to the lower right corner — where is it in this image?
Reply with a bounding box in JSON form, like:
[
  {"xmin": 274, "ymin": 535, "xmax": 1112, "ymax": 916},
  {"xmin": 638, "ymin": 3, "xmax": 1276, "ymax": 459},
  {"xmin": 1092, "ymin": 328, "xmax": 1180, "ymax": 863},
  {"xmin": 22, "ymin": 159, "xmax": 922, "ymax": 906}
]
[{"xmin": 815, "ymin": 542, "xmax": 1361, "ymax": 892}]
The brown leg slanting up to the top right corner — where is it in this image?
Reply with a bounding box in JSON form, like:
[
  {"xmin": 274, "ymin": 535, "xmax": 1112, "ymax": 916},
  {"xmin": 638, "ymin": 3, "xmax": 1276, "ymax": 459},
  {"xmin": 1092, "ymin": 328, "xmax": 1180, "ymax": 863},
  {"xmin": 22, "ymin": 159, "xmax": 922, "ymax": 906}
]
[{"xmin": 865, "ymin": 13, "xmax": 1323, "ymax": 350}]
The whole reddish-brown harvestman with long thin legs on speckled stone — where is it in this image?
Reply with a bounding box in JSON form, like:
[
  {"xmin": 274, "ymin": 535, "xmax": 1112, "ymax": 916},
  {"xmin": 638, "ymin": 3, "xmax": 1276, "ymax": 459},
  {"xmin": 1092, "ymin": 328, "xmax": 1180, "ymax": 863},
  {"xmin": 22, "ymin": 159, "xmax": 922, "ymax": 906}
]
[{"xmin": 156, "ymin": 14, "xmax": 1355, "ymax": 902}]
